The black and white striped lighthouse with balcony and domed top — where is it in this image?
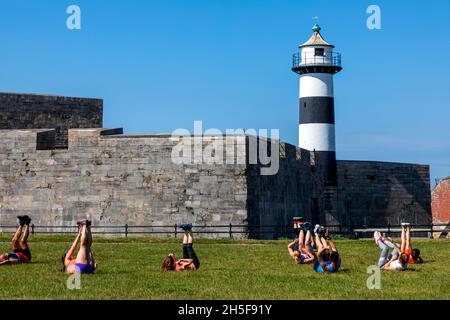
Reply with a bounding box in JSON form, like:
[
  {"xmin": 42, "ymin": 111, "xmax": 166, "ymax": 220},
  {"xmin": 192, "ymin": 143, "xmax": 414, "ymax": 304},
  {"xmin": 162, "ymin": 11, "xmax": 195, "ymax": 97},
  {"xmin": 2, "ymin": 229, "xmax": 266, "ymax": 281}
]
[{"xmin": 292, "ymin": 23, "xmax": 342, "ymax": 185}]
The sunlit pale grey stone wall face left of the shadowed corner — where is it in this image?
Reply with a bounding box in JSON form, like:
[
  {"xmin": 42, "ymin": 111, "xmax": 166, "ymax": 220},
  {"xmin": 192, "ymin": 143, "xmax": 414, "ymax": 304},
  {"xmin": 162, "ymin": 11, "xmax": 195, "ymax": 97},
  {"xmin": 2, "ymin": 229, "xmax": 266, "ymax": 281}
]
[{"xmin": 0, "ymin": 129, "xmax": 247, "ymax": 236}]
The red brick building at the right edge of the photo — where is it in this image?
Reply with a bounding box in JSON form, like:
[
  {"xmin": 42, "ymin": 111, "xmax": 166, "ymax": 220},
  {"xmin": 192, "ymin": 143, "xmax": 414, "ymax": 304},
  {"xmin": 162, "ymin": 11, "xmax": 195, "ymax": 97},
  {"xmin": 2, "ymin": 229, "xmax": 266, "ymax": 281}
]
[{"xmin": 431, "ymin": 177, "xmax": 450, "ymax": 223}]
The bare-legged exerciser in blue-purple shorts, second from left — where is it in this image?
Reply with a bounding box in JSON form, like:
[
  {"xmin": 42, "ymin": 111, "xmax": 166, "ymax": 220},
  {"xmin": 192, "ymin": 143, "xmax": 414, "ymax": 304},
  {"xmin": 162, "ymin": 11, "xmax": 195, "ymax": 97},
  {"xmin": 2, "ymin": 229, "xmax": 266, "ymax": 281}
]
[{"xmin": 62, "ymin": 220, "xmax": 97, "ymax": 274}]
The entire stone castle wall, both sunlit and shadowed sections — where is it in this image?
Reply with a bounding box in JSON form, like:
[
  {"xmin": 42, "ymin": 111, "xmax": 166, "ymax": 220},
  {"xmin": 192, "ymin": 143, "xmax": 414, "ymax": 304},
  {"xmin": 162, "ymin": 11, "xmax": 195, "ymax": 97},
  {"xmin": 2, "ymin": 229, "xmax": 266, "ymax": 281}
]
[{"xmin": 0, "ymin": 94, "xmax": 431, "ymax": 239}]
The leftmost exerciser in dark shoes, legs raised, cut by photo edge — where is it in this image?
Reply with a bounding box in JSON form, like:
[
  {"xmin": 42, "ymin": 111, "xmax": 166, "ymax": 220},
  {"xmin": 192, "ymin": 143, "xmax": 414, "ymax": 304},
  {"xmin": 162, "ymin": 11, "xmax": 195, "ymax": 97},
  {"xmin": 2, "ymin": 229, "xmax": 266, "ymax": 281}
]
[{"xmin": 0, "ymin": 216, "xmax": 31, "ymax": 265}]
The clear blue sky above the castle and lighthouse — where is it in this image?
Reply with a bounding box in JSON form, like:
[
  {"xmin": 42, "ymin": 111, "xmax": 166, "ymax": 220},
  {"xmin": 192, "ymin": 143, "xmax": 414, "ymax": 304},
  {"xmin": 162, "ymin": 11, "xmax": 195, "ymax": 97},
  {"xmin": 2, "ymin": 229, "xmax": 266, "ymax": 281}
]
[{"xmin": 0, "ymin": 0, "xmax": 450, "ymax": 186}]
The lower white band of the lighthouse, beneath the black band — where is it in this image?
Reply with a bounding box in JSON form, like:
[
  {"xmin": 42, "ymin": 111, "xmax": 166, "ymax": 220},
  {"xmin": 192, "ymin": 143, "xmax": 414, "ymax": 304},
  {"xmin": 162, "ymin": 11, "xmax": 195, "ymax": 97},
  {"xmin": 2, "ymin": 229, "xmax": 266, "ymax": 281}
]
[{"xmin": 298, "ymin": 123, "xmax": 336, "ymax": 152}]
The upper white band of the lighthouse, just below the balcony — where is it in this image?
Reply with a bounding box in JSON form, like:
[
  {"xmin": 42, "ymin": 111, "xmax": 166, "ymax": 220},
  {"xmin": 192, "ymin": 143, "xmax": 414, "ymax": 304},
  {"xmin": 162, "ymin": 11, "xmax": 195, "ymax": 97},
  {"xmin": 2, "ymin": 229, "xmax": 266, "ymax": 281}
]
[{"xmin": 300, "ymin": 73, "xmax": 334, "ymax": 98}]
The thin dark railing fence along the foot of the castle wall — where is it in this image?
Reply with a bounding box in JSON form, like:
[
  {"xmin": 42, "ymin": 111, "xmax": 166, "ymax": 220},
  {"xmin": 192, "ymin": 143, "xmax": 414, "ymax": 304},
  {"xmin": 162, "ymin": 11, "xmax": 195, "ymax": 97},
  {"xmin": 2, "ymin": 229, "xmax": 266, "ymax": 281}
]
[{"xmin": 0, "ymin": 223, "xmax": 450, "ymax": 239}]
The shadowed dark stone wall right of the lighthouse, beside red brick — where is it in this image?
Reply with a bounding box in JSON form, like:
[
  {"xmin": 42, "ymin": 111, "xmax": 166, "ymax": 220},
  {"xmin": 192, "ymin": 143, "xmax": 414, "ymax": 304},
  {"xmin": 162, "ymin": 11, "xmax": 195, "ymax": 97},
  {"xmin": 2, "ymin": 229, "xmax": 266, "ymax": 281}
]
[{"xmin": 327, "ymin": 161, "xmax": 432, "ymax": 226}]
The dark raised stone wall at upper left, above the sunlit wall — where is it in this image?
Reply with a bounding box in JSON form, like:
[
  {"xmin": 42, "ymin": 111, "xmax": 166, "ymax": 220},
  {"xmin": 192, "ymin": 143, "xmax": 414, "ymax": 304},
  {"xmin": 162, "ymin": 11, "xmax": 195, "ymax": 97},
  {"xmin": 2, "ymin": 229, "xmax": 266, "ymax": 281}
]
[{"xmin": 0, "ymin": 93, "xmax": 103, "ymax": 148}]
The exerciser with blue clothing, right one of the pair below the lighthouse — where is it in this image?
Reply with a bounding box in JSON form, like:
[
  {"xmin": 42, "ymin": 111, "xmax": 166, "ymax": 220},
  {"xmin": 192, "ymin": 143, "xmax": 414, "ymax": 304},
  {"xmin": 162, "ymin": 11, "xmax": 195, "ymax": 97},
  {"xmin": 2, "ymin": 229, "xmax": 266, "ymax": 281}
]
[{"xmin": 314, "ymin": 225, "xmax": 341, "ymax": 273}]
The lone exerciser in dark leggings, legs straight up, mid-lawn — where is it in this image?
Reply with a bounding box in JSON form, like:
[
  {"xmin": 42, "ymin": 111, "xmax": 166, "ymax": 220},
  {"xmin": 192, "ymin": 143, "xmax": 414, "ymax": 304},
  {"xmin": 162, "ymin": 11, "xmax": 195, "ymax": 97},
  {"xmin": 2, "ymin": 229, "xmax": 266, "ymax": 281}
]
[{"xmin": 161, "ymin": 224, "xmax": 200, "ymax": 271}]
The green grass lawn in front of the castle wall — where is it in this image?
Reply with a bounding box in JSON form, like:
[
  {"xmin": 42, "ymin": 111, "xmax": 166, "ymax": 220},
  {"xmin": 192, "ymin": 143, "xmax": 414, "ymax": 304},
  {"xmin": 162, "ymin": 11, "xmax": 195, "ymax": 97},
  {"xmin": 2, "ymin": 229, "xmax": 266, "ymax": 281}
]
[{"xmin": 0, "ymin": 235, "xmax": 450, "ymax": 300}]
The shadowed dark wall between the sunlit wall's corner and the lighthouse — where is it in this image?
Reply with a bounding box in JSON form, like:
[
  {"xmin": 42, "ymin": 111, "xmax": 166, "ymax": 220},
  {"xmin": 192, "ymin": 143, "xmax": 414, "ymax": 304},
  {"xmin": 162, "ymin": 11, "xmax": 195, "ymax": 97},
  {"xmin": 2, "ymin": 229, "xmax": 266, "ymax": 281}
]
[{"xmin": 247, "ymin": 138, "xmax": 325, "ymax": 239}]
